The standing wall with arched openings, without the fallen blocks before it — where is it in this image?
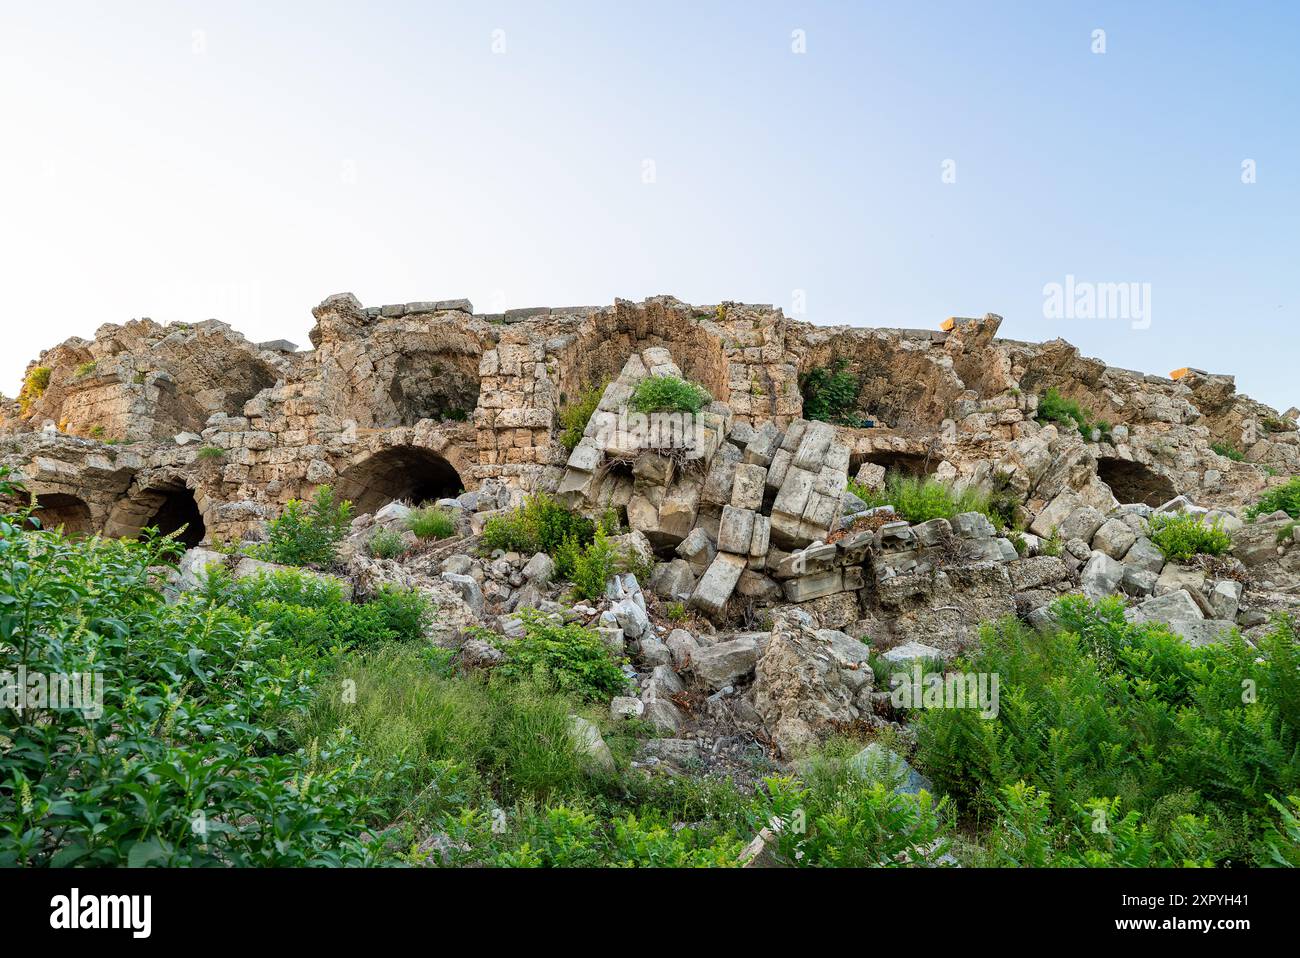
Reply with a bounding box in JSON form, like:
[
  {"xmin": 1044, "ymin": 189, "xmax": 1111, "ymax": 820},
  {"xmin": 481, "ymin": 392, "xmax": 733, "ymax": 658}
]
[{"xmin": 0, "ymin": 294, "xmax": 1300, "ymax": 545}]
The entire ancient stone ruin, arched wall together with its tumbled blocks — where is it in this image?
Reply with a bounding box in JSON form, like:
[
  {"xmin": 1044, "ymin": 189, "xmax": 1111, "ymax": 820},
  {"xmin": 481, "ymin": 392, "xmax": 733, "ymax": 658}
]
[{"xmin": 0, "ymin": 294, "xmax": 1300, "ymax": 747}]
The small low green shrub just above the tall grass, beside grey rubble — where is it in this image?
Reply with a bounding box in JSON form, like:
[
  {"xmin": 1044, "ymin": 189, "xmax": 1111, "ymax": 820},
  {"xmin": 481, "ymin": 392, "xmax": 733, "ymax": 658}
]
[{"xmin": 497, "ymin": 608, "xmax": 628, "ymax": 701}]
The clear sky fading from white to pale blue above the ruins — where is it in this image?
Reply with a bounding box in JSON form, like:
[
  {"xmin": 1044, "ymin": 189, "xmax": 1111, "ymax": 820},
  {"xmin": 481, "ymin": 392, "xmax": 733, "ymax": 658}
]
[{"xmin": 0, "ymin": 0, "xmax": 1300, "ymax": 409}]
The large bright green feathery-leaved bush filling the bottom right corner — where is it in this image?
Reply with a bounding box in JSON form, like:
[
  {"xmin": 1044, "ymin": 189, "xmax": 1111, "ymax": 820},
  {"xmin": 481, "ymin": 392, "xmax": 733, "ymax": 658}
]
[{"xmin": 917, "ymin": 597, "xmax": 1300, "ymax": 864}]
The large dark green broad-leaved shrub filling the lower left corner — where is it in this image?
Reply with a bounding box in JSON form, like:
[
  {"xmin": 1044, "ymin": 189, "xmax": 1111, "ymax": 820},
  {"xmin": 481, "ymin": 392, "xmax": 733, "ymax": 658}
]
[{"xmin": 0, "ymin": 515, "xmax": 372, "ymax": 866}]
